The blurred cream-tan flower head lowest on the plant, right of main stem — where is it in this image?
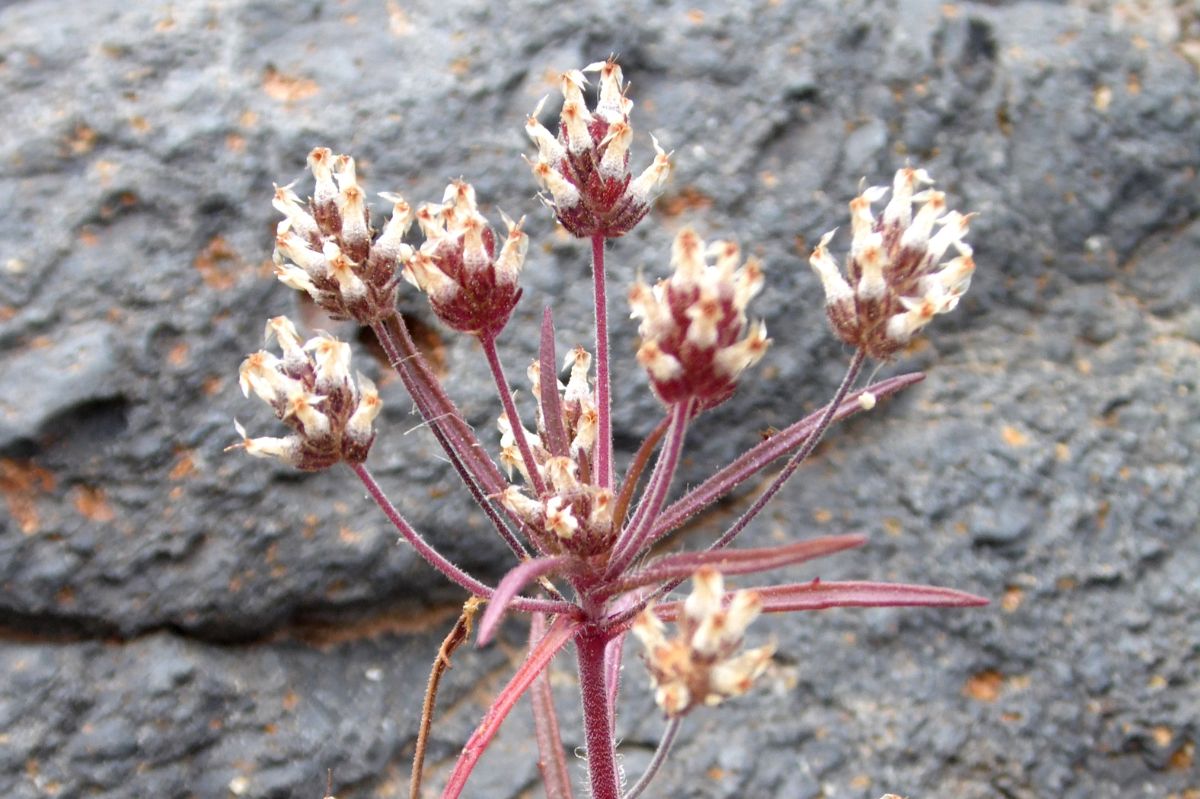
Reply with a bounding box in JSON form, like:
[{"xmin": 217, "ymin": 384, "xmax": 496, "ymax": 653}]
[{"xmin": 632, "ymin": 566, "xmax": 775, "ymax": 717}]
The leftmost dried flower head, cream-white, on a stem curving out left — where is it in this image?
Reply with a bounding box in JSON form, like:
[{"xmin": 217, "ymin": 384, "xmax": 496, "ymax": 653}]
[{"xmin": 230, "ymin": 317, "xmax": 383, "ymax": 471}]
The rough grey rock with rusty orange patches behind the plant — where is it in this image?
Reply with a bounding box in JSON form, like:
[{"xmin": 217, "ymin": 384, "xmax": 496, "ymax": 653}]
[{"xmin": 0, "ymin": 0, "xmax": 1200, "ymax": 799}]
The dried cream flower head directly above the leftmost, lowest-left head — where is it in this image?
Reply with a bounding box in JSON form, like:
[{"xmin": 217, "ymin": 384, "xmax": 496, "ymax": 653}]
[{"xmin": 272, "ymin": 148, "xmax": 413, "ymax": 325}]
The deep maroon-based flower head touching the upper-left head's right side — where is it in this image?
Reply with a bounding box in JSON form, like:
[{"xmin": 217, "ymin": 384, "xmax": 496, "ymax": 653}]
[{"xmin": 404, "ymin": 180, "xmax": 529, "ymax": 336}]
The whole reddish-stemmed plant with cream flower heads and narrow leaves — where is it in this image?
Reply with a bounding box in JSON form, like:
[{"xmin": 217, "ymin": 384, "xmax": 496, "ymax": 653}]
[{"xmin": 230, "ymin": 59, "xmax": 983, "ymax": 799}]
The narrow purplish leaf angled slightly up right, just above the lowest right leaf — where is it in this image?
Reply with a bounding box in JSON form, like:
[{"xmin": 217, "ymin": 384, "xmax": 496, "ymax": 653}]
[{"xmin": 604, "ymin": 535, "xmax": 866, "ymax": 593}]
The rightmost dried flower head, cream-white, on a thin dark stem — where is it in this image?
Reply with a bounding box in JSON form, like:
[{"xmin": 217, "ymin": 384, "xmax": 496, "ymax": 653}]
[{"xmin": 809, "ymin": 167, "xmax": 974, "ymax": 359}]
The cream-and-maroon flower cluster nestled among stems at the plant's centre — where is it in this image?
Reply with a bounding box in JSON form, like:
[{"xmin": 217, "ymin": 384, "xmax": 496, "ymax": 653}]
[{"xmin": 497, "ymin": 347, "xmax": 613, "ymax": 557}]
